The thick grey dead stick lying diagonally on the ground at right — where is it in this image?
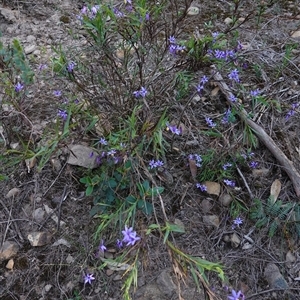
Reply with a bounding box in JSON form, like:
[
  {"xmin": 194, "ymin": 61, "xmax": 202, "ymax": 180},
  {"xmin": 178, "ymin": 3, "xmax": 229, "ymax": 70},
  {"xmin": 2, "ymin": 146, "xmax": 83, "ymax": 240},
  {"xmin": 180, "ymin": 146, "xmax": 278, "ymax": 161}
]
[{"xmin": 212, "ymin": 66, "xmax": 300, "ymax": 198}]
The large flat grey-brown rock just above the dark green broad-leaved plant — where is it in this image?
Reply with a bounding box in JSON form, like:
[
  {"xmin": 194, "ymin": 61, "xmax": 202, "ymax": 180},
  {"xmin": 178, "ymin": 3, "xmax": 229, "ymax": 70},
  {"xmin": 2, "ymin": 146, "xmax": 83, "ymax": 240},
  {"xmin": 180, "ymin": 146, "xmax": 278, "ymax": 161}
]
[{"xmin": 68, "ymin": 145, "xmax": 98, "ymax": 169}]
